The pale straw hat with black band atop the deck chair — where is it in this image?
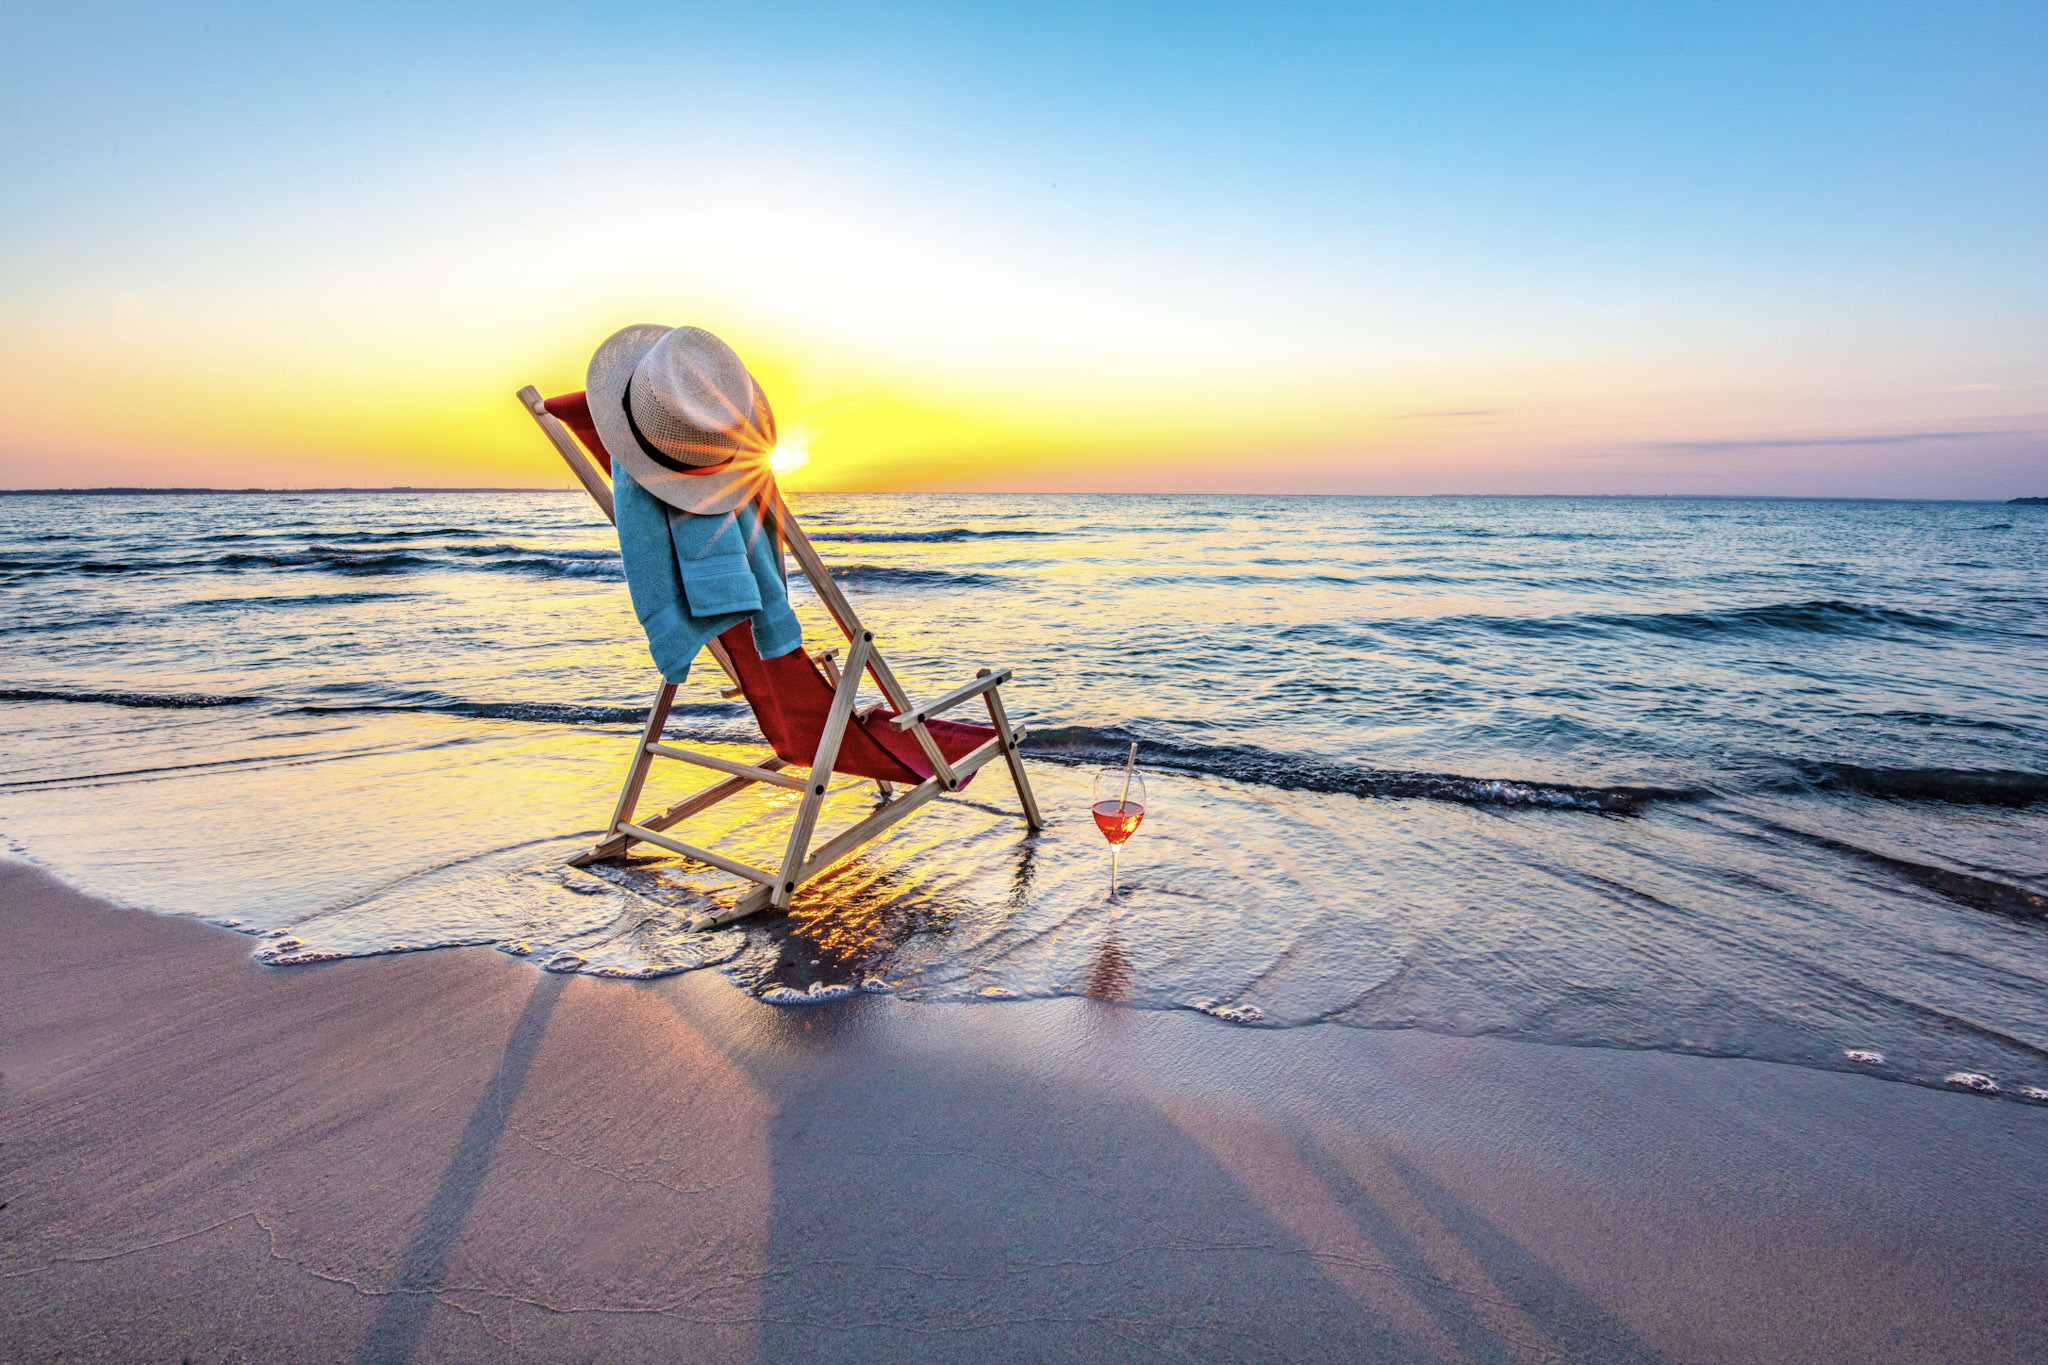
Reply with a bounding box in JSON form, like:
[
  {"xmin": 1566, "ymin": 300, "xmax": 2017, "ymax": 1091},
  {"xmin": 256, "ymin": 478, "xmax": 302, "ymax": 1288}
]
[{"xmin": 584, "ymin": 323, "xmax": 774, "ymax": 514}]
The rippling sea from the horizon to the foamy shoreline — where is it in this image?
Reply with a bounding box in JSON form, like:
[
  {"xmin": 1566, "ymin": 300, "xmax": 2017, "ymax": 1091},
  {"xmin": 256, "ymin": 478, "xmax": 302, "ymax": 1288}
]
[{"xmin": 0, "ymin": 493, "xmax": 2048, "ymax": 1101}]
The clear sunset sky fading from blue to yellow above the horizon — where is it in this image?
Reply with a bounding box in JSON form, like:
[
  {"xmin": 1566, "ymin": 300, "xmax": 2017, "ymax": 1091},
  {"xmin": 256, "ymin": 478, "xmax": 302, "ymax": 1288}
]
[{"xmin": 0, "ymin": 0, "xmax": 2048, "ymax": 497}]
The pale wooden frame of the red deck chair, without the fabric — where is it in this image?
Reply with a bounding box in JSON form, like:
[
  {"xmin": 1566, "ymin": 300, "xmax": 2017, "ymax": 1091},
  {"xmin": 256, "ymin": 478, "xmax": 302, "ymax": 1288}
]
[{"xmin": 518, "ymin": 385, "xmax": 1044, "ymax": 929}]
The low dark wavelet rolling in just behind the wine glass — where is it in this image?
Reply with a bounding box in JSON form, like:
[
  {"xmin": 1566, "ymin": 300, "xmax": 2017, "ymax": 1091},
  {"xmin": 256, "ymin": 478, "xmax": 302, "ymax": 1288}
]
[{"xmin": 1024, "ymin": 724, "xmax": 1702, "ymax": 814}]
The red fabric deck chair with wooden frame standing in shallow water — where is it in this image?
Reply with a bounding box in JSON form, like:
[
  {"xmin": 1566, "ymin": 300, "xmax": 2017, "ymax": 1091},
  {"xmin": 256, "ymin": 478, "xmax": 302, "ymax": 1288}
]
[{"xmin": 518, "ymin": 385, "xmax": 1044, "ymax": 929}]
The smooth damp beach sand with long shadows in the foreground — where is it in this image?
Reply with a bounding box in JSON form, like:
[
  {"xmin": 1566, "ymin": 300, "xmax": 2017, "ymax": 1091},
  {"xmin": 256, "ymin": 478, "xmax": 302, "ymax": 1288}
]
[{"xmin": 0, "ymin": 864, "xmax": 2048, "ymax": 1363}]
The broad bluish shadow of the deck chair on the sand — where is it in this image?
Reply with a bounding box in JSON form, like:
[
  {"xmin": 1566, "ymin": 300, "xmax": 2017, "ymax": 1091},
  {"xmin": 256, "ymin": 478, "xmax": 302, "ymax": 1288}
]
[{"xmin": 756, "ymin": 994, "xmax": 1657, "ymax": 1361}]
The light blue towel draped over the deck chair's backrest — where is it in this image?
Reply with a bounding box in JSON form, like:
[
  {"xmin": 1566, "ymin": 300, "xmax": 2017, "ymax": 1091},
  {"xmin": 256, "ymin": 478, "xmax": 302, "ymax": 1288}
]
[{"xmin": 612, "ymin": 465, "xmax": 803, "ymax": 684}]
